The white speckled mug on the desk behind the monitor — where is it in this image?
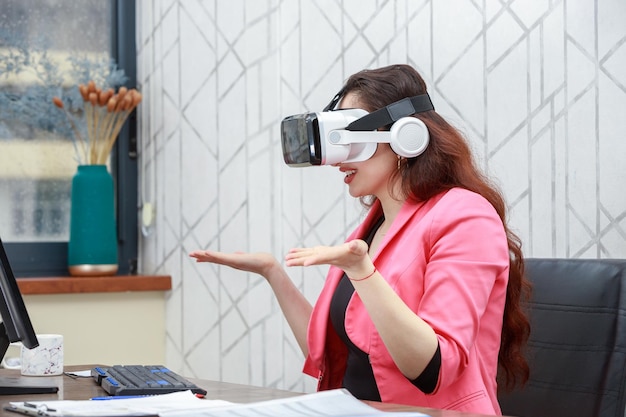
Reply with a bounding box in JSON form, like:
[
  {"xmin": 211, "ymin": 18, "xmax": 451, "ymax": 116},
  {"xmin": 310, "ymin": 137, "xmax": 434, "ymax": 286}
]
[{"xmin": 20, "ymin": 334, "xmax": 63, "ymax": 376}]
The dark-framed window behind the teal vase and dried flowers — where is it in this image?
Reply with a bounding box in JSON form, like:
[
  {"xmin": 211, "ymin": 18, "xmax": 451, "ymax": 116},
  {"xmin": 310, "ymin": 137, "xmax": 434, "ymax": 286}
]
[{"xmin": 0, "ymin": 0, "xmax": 137, "ymax": 277}]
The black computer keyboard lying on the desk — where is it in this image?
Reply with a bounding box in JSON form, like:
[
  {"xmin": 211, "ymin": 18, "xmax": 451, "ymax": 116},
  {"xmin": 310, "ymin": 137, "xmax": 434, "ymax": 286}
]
[{"xmin": 91, "ymin": 365, "xmax": 206, "ymax": 396}]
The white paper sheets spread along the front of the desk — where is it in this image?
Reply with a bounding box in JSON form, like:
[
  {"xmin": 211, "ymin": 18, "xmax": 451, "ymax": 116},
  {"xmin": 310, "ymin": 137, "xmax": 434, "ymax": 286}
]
[{"xmin": 4, "ymin": 389, "xmax": 426, "ymax": 417}]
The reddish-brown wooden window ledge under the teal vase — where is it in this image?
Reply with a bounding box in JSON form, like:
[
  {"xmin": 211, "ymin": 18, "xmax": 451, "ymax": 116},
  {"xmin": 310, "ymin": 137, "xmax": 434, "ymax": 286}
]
[{"xmin": 17, "ymin": 275, "xmax": 172, "ymax": 295}]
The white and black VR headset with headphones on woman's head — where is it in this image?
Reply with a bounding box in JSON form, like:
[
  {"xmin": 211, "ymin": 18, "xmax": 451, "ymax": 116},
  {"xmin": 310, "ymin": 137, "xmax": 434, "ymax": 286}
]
[{"xmin": 280, "ymin": 90, "xmax": 434, "ymax": 167}]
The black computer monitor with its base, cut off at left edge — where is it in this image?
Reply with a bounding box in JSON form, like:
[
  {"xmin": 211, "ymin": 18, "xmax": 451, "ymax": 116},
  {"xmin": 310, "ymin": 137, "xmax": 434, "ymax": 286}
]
[{"xmin": 0, "ymin": 239, "xmax": 58, "ymax": 395}]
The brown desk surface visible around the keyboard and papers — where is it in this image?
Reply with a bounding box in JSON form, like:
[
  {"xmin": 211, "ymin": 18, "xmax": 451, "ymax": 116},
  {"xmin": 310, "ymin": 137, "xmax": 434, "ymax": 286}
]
[{"xmin": 0, "ymin": 365, "xmax": 498, "ymax": 417}]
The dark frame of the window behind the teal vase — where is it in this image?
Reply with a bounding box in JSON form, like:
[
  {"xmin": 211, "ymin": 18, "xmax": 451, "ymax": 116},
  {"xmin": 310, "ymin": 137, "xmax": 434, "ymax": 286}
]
[{"xmin": 3, "ymin": 0, "xmax": 139, "ymax": 277}]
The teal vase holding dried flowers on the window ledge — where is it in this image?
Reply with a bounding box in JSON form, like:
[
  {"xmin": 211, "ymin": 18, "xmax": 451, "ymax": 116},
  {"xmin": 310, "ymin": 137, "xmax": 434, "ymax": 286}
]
[{"xmin": 68, "ymin": 165, "xmax": 118, "ymax": 276}]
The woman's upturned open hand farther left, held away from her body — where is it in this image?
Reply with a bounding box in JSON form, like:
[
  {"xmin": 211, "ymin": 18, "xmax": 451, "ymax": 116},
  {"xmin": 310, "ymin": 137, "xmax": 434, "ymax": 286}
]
[{"xmin": 189, "ymin": 250, "xmax": 280, "ymax": 278}]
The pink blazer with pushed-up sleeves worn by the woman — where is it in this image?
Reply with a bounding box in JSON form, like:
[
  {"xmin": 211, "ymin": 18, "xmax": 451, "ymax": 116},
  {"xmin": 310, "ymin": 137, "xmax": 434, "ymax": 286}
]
[{"xmin": 304, "ymin": 188, "xmax": 509, "ymax": 415}]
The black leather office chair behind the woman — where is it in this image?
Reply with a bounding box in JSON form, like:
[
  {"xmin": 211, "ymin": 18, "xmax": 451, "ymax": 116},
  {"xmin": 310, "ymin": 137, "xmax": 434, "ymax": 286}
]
[{"xmin": 499, "ymin": 258, "xmax": 626, "ymax": 417}]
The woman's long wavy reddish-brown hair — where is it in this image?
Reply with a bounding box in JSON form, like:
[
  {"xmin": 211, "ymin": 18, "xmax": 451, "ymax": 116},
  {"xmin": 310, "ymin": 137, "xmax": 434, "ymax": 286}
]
[{"xmin": 343, "ymin": 65, "xmax": 531, "ymax": 388}]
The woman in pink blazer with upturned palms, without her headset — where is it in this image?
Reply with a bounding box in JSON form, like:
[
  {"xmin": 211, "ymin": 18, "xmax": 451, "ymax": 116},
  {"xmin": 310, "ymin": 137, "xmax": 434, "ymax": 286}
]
[{"xmin": 191, "ymin": 65, "xmax": 529, "ymax": 414}]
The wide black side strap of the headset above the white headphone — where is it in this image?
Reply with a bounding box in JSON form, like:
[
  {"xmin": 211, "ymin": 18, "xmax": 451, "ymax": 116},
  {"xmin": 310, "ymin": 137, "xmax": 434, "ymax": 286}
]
[{"xmin": 344, "ymin": 94, "xmax": 435, "ymax": 131}]
